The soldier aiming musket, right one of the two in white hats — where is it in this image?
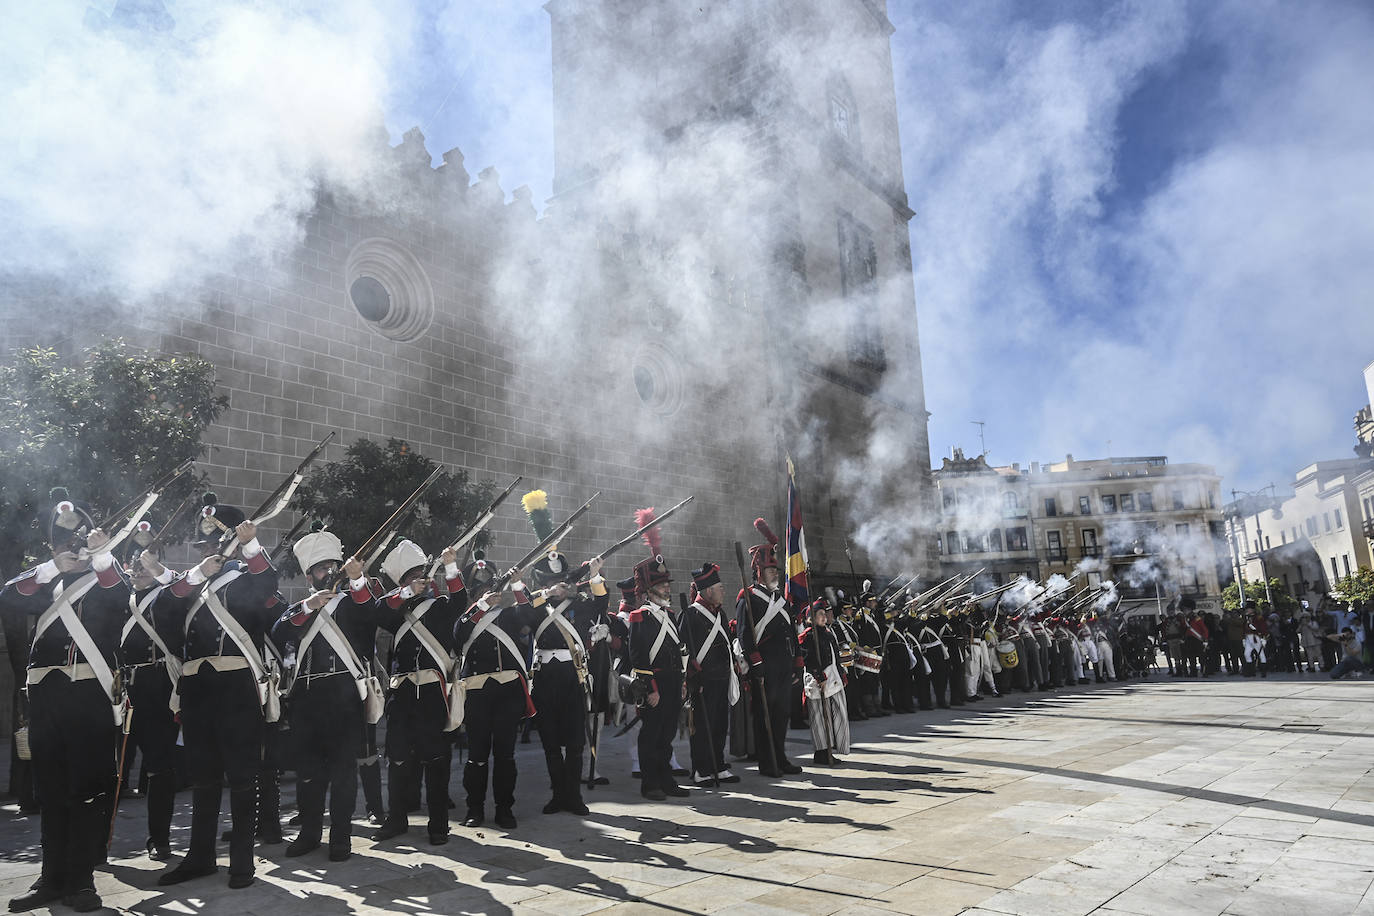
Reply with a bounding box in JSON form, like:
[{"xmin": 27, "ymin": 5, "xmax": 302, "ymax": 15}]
[{"xmin": 376, "ymin": 540, "xmax": 467, "ymax": 846}]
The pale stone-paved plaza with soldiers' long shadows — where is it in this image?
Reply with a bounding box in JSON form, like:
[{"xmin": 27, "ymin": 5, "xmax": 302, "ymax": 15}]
[{"xmin": 0, "ymin": 674, "xmax": 1374, "ymax": 916}]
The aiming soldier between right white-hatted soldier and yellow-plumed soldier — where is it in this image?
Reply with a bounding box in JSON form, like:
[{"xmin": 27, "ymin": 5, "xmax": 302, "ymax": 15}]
[{"xmin": 453, "ymin": 581, "xmax": 543, "ymax": 829}]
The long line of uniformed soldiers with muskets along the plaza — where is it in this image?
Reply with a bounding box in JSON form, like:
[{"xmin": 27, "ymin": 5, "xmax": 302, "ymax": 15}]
[{"xmin": 0, "ymin": 492, "xmax": 1148, "ymax": 912}]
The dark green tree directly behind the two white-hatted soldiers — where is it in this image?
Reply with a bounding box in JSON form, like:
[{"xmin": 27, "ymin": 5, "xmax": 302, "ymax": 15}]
[{"xmin": 278, "ymin": 438, "xmax": 496, "ymax": 575}]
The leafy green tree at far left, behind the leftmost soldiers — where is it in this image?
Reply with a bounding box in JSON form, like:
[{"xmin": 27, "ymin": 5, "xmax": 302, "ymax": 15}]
[{"xmin": 0, "ymin": 339, "xmax": 228, "ymax": 571}]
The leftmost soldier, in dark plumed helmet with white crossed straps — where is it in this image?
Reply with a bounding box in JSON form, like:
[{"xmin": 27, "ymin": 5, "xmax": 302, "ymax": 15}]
[{"xmin": 0, "ymin": 488, "xmax": 132, "ymax": 913}]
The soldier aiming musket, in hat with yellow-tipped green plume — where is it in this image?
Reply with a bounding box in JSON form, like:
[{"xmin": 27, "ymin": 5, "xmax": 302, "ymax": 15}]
[{"xmin": 530, "ymin": 549, "xmax": 609, "ymax": 816}]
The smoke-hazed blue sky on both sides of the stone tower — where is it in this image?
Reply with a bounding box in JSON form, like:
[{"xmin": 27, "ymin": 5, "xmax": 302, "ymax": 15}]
[{"xmin": 10, "ymin": 0, "xmax": 1374, "ymax": 502}]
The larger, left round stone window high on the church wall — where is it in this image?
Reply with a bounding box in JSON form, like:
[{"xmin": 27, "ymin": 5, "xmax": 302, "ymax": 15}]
[{"xmin": 344, "ymin": 238, "xmax": 434, "ymax": 342}]
